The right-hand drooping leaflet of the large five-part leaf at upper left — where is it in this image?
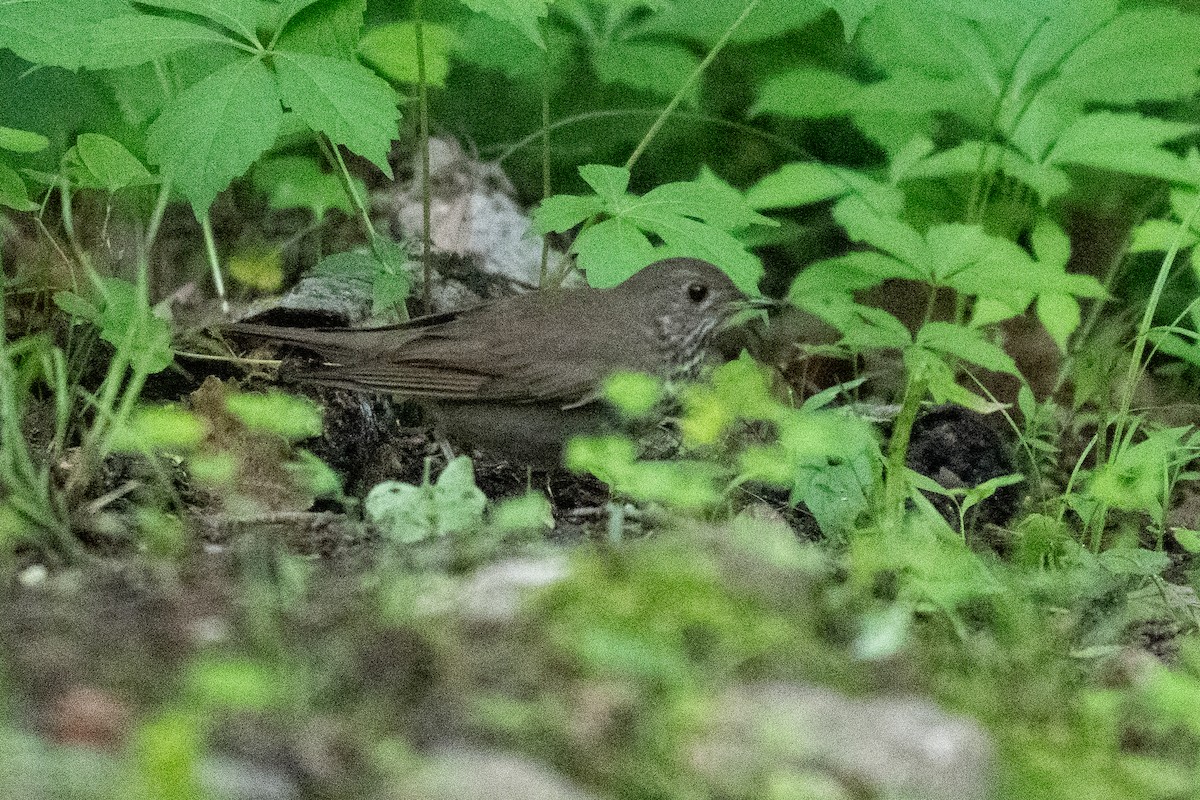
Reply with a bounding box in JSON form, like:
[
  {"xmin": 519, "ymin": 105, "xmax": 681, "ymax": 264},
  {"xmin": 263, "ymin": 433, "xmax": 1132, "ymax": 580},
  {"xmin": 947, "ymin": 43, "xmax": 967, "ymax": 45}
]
[{"xmin": 275, "ymin": 52, "xmax": 400, "ymax": 178}]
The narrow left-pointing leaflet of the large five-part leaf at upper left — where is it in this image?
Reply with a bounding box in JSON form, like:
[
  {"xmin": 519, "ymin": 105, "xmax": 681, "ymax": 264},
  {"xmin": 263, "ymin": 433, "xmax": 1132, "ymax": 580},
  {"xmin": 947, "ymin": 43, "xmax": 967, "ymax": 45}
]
[{"xmin": 80, "ymin": 14, "xmax": 236, "ymax": 70}]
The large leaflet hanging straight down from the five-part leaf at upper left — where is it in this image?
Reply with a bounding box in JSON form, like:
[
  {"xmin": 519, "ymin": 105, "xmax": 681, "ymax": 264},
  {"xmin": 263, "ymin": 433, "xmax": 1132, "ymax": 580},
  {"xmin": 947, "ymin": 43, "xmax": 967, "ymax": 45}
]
[{"xmin": 146, "ymin": 60, "xmax": 283, "ymax": 215}]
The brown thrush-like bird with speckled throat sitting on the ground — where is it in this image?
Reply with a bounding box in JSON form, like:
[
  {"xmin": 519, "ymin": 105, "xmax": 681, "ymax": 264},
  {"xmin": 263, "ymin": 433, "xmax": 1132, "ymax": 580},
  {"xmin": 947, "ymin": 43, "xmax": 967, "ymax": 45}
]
[{"xmin": 222, "ymin": 258, "xmax": 755, "ymax": 467}]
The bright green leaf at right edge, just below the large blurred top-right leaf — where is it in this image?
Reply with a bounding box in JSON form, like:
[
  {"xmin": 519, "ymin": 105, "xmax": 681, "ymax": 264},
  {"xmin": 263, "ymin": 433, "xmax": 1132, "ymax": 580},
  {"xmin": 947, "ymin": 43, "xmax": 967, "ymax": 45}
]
[{"xmin": 1045, "ymin": 112, "xmax": 1200, "ymax": 182}]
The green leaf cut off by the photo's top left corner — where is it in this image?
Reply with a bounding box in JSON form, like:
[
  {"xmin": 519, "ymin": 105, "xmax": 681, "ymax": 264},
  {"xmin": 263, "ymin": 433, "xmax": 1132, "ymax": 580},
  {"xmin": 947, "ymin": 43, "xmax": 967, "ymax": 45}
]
[{"xmin": 0, "ymin": 0, "xmax": 132, "ymax": 70}]
